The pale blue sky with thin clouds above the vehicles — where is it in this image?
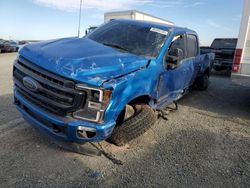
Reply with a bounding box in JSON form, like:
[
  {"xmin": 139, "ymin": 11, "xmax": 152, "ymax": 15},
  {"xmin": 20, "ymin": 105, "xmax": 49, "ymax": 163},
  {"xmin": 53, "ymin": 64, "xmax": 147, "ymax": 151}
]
[{"xmin": 0, "ymin": 0, "xmax": 243, "ymax": 45}]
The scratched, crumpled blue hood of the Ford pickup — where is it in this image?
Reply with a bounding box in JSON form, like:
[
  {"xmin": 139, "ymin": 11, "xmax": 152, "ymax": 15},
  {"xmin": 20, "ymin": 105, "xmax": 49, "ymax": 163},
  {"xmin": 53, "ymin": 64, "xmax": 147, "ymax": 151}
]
[{"xmin": 19, "ymin": 38, "xmax": 148, "ymax": 86}]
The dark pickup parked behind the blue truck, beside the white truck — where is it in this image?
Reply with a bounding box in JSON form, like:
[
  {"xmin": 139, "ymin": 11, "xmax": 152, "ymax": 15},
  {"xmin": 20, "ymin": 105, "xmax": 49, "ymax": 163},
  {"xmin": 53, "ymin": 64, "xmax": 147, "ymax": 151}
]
[{"xmin": 201, "ymin": 38, "xmax": 237, "ymax": 74}]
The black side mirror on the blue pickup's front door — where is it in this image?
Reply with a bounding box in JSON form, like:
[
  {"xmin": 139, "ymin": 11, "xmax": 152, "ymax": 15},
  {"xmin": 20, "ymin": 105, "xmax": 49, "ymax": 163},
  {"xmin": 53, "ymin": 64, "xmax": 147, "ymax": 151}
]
[{"xmin": 165, "ymin": 48, "xmax": 184, "ymax": 69}]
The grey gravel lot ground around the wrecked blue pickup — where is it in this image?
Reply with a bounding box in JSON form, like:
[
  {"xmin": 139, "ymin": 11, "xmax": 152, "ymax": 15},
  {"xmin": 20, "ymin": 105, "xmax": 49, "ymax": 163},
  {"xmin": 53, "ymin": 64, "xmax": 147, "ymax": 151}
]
[{"xmin": 0, "ymin": 54, "xmax": 250, "ymax": 187}]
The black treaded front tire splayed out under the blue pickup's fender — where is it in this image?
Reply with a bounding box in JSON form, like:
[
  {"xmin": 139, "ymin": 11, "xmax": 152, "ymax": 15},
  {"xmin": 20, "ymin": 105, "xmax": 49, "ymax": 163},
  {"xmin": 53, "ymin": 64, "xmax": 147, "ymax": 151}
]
[{"xmin": 109, "ymin": 104, "xmax": 157, "ymax": 146}]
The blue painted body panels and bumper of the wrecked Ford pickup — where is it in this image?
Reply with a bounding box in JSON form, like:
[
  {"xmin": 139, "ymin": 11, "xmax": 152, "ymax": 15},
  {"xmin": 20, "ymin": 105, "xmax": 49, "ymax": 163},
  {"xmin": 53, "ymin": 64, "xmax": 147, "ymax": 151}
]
[{"xmin": 15, "ymin": 21, "xmax": 213, "ymax": 142}]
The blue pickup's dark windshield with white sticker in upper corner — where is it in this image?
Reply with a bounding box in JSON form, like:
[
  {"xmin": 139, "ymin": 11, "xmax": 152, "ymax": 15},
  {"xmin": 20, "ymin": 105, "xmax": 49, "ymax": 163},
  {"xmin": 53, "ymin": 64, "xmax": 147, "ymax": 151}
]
[{"xmin": 87, "ymin": 20, "xmax": 168, "ymax": 57}]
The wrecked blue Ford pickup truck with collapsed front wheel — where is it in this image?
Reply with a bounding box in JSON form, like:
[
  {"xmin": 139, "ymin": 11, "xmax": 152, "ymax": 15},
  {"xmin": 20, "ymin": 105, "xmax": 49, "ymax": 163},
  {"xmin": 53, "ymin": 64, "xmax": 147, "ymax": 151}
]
[{"xmin": 13, "ymin": 20, "xmax": 214, "ymax": 145}]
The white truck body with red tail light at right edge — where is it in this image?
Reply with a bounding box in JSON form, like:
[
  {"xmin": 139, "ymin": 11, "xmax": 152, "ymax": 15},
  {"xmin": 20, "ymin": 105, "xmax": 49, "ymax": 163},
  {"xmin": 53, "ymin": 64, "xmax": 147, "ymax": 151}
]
[{"xmin": 232, "ymin": 0, "xmax": 250, "ymax": 86}]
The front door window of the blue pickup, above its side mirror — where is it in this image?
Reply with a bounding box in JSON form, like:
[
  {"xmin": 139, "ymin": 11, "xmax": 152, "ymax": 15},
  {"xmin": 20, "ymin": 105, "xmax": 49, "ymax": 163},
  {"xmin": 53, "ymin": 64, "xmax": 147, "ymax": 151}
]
[{"xmin": 168, "ymin": 35, "xmax": 185, "ymax": 59}]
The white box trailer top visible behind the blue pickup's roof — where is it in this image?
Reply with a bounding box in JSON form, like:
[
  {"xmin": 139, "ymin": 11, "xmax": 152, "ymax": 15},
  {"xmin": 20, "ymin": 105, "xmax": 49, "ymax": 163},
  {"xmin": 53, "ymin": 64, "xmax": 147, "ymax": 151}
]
[{"xmin": 104, "ymin": 10, "xmax": 174, "ymax": 25}]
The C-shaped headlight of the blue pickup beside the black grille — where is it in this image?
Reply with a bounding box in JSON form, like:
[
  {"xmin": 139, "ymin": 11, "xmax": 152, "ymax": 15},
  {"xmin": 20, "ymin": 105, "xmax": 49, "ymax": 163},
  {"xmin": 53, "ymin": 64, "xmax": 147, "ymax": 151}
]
[{"xmin": 73, "ymin": 84, "xmax": 111, "ymax": 123}]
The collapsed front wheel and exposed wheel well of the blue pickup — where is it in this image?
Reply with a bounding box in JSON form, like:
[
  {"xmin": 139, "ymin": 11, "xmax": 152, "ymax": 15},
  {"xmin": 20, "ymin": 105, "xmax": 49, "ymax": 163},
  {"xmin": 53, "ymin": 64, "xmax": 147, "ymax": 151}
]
[{"xmin": 108, "ymin": 95, "xmax": 157, "ymax": 146}]
